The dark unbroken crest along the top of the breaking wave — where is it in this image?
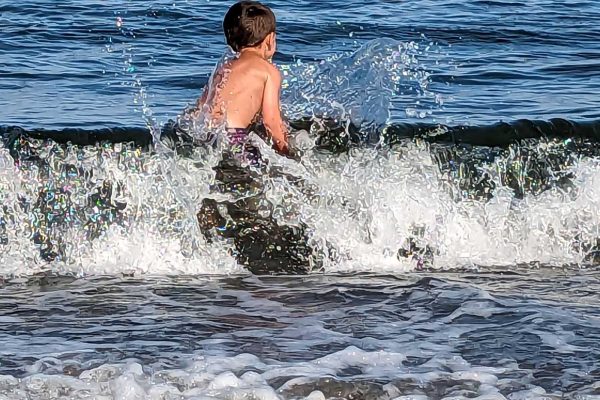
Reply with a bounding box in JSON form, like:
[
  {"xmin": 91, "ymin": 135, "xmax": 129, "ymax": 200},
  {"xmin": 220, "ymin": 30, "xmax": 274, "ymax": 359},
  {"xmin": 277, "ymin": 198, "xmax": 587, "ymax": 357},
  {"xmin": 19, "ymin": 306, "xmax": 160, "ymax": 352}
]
[{"xmin": 0, "ymin": 117, "xmax": 600, "ymax": 151}]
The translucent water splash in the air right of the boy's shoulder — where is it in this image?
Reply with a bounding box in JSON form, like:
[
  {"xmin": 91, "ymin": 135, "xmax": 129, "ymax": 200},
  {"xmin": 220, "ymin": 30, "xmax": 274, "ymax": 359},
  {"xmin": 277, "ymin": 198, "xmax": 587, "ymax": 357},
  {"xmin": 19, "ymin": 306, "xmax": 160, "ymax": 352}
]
[{"xmin": 280, "ymin": 39, "xmax": 442, "ymax": 132}]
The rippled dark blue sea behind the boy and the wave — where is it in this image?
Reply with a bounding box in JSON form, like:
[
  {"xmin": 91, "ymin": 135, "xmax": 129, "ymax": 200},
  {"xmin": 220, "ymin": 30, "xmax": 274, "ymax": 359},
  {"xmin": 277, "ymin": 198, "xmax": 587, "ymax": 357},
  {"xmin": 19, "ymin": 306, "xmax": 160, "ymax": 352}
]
[{"xmin": 0, "ymin": 0, "xmax": 600, "ymax": 128}]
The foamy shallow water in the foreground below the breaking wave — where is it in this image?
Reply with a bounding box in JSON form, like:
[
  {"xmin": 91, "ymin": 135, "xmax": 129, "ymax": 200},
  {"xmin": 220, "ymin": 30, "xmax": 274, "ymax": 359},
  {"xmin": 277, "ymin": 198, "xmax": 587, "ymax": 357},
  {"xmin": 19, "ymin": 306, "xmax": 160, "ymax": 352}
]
[{"xmin": 0, "ymin": 269, "xmax": 600, "ymax": 399}]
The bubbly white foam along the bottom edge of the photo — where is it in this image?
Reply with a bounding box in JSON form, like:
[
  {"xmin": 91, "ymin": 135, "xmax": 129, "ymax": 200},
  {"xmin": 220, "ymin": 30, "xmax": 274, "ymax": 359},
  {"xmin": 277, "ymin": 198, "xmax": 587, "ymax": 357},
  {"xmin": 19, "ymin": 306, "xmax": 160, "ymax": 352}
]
[{"xmin": 0, "ymin": 347, "xmax": 576, "ymax": 400}]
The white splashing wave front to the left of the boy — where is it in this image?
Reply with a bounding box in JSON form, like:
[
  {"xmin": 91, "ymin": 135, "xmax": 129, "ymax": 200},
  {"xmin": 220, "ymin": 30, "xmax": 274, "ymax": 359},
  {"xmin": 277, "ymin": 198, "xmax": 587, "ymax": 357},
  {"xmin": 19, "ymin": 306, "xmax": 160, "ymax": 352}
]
[{"xmin": 1, "ymin": 137, "xmax": 238, "ymax": 274}]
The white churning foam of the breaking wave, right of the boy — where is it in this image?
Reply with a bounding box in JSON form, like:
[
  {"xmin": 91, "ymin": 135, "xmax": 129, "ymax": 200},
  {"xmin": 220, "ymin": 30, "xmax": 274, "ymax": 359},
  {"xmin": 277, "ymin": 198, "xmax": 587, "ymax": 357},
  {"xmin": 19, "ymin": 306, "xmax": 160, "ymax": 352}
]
[{"xmin": 262, "ymin": 139, "xmax": 600, "ymax": 271}]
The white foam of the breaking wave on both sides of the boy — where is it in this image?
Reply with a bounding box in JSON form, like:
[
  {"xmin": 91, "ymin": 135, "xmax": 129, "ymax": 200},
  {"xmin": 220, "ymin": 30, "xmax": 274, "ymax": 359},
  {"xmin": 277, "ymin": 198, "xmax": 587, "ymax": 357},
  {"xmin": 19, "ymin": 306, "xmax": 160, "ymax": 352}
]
[{"xmin": 0, "ymin": 134, "xmax": 600, "ymax": 275}]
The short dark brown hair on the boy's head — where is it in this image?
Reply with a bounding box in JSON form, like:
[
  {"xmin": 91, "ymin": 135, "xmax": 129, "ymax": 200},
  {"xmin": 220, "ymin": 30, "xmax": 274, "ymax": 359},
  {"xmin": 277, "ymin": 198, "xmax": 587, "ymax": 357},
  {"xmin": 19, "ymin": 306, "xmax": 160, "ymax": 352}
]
[{"xmin": 223, "ymin": 1, "xmax": 276, "ymax": 52}]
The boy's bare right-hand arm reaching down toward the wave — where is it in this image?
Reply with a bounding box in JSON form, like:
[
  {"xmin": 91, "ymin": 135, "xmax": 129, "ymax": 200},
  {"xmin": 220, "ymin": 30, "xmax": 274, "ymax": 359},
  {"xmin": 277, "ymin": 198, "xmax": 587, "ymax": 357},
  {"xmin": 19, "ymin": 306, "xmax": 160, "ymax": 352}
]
[{"xmin": 262, "ymin": 64, "xmax": 288, "ymax": 155}]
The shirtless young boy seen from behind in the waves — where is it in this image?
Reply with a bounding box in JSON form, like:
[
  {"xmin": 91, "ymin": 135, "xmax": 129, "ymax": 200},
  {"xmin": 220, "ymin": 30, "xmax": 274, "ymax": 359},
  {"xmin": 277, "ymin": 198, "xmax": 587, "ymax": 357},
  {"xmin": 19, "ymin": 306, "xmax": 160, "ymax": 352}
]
[{"xmin": 197, "ymin": 1, "xmax": 288, "ymax": 161}]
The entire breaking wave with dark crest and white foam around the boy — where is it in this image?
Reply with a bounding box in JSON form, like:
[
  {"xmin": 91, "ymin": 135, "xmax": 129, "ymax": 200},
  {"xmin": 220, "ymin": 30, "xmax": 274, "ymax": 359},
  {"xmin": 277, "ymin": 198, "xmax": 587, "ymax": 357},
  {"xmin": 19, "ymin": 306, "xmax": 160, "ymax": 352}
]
[{"xmin": 0, "ymin": 119, "xmax": 600, "ymax": 274}]
